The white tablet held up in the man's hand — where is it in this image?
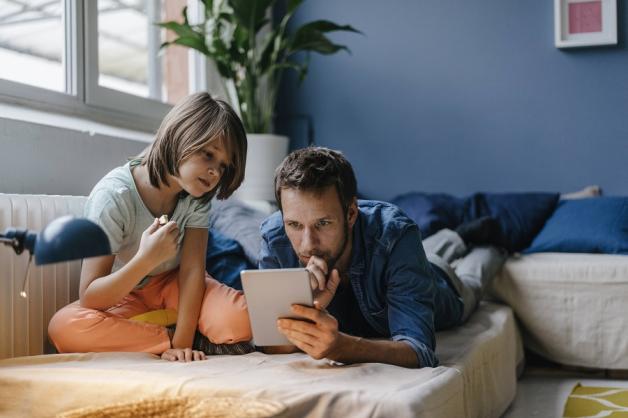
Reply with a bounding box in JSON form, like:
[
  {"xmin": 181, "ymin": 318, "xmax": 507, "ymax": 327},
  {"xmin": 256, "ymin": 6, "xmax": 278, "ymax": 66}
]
[{"xmin": 240, "ymin": 268, "xmax": 314, "ymax": 346}]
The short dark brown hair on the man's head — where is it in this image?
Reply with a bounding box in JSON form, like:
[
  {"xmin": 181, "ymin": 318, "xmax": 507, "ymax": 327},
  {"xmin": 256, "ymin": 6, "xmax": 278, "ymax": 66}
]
[{"xmin": 275, "ymin": 147, "xmax": 357, "ymax": 214}]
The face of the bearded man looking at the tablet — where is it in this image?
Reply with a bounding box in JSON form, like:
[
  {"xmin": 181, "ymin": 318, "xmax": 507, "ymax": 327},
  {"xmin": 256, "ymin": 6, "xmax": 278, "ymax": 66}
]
[{"xmin": 281, "ymin": 186, "xmax": 352, "ymax": 271}]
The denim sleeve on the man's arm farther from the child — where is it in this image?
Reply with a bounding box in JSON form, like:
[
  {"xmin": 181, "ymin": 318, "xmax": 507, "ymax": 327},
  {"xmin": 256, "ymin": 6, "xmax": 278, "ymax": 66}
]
[{"xmin": 386, "ymin": 227, "xmax": 438, "ymax": 367}]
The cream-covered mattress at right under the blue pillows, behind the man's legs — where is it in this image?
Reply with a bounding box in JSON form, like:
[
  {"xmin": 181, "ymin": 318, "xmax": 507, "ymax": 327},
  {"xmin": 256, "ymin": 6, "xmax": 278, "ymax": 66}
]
[{"xmin": 491, "ymin": 253, "xmax": 628, "ymax": 369}]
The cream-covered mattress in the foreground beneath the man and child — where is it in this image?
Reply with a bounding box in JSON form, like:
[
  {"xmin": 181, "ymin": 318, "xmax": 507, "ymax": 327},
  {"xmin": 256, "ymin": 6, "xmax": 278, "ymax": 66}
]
[{"xmin": 0, "ymin": 303, "xmax": 523, "ymax": 418}]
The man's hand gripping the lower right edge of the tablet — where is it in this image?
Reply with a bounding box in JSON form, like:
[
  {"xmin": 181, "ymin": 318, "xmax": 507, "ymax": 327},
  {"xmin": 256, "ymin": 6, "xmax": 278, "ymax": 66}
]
[{"xmin": 277, "ymin": 305, "xmax": 345, "ymax": 360}]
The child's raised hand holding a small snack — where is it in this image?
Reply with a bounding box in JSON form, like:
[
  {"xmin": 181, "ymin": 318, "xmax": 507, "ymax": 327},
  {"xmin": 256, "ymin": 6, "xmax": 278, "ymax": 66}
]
[{"xmin": 137, "ymin": 219, "xmax": 179, "ymax": 266}]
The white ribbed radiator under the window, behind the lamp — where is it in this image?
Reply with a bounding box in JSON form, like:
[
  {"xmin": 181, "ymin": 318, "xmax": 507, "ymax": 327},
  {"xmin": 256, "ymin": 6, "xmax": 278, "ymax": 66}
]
[{"xmin": 0, "ymin": 193, "xmax": 85, "ymax": 359}]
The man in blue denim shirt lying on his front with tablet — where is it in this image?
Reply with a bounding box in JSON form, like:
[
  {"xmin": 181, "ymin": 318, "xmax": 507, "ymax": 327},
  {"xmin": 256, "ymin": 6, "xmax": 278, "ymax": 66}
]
[{"xmin": 259, "ymin": 148, "xmax": 505, "ymax": 367}]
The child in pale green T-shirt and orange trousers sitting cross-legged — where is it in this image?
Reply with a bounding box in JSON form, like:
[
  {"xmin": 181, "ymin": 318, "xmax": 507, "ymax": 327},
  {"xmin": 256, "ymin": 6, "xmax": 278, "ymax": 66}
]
[{"xmin": 48, "ymin": 93, "xmax": 251, "ymax": 361}]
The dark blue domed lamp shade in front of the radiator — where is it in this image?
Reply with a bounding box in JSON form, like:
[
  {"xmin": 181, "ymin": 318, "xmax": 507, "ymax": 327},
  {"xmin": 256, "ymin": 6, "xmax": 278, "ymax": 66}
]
[{"xmin": 32, "ymin": 216, "xmax": 111, "ymax": 265}]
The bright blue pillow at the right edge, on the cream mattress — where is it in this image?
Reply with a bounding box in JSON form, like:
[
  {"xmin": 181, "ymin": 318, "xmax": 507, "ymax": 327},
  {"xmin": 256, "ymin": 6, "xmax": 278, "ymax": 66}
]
[{"xmin": 524, "ymin": 197, "xmax": 628, "ymax": 254}]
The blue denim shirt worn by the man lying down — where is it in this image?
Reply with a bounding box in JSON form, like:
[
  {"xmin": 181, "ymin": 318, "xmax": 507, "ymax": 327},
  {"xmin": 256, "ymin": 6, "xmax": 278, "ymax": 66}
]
[{"xmin": 259, "ymin": 200, "xmax": 462, "ymax": 367}]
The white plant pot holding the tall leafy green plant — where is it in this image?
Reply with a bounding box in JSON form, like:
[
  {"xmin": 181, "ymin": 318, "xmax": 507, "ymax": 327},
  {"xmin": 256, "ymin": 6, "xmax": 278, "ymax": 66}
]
[{"xmin": 236, "ymin": 134, "xmax": 290, "ymax": 202}]
